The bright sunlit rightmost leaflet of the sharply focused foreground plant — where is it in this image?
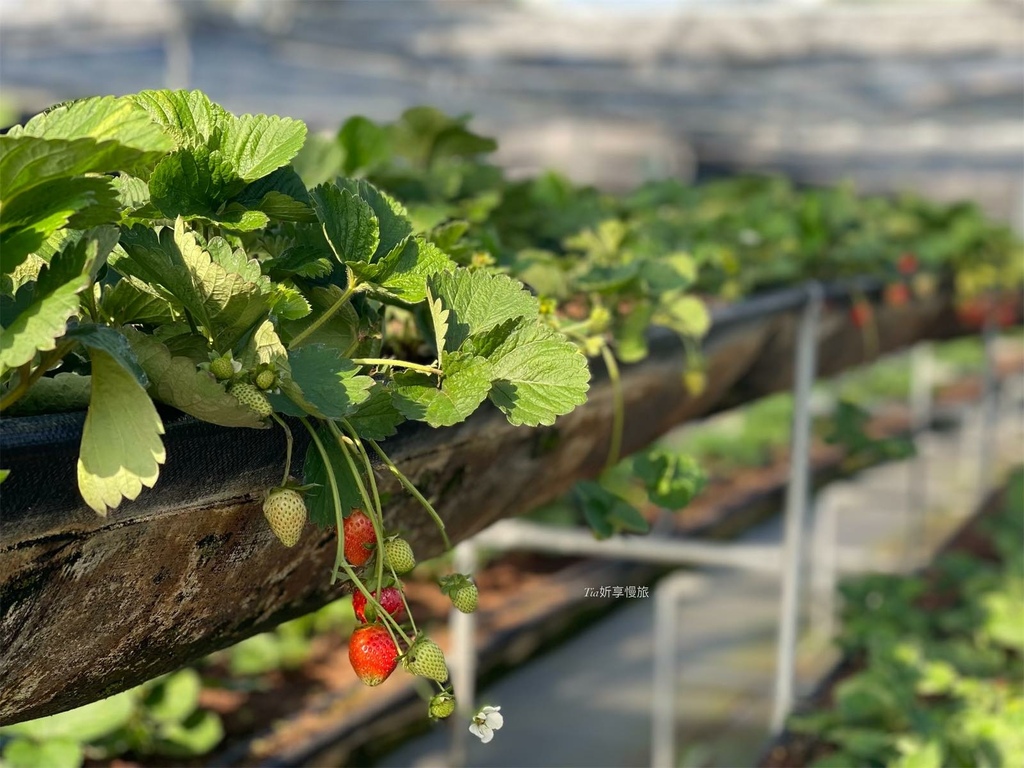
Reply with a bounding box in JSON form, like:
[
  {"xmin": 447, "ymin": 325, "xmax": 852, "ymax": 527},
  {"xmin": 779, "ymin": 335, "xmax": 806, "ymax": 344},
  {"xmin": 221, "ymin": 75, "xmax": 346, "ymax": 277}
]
[{"xmin": 467, "ymin": 319, "xmax": 590, "ymax": 427}]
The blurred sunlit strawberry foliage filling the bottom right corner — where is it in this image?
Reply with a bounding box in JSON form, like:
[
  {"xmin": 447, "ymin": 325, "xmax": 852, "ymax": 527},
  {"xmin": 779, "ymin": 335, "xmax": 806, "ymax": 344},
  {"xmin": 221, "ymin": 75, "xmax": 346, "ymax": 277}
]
[{"xmin": 787, "ymin": 471, "xmax": 1024, "ymax": 767}]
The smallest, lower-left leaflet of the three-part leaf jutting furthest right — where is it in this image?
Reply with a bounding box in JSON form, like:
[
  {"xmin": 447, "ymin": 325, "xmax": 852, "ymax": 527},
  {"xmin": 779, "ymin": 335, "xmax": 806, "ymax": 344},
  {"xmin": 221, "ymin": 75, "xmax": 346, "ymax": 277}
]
[{"xmin": 393, "ymin": 352, "xmax": 492, "ymax": 427}]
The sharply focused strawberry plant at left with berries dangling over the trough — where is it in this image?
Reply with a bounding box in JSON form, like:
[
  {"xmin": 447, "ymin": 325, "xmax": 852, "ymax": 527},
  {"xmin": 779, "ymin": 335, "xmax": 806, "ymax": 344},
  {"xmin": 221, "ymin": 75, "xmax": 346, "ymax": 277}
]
[{"xmin": 0, "ymin": 91, "xmax": 589, "ymax": 720}]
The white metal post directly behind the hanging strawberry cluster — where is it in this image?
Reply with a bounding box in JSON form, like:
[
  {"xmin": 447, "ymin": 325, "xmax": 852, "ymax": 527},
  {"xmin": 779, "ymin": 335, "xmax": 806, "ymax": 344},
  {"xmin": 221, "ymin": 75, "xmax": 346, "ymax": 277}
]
[{"xmin": 449, "ymin": 540, "xmax": 477, "ymax": 768}]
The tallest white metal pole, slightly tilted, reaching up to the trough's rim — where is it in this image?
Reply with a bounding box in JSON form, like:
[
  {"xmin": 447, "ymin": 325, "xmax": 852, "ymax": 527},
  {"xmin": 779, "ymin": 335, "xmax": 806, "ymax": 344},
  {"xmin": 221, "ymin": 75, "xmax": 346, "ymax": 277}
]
[{"xmin": 771, "ymin": 283, "xmax": 823, "ymax": 733}]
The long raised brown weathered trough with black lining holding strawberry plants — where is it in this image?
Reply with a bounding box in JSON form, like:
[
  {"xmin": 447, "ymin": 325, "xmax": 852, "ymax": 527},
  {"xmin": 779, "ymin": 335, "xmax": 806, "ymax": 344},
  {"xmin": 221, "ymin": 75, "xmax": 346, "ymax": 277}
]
[{"xmin": 0, "ymin": 283, "xmax": 991, "ymax": 724}]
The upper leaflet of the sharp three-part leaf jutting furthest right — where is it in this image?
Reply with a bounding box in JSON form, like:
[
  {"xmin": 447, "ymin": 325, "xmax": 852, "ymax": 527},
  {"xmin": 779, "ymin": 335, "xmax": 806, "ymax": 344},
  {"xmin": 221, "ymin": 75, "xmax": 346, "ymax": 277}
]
[{"xmin": 429, "ymin": 269, "xmax": 539, "ymax": 350}]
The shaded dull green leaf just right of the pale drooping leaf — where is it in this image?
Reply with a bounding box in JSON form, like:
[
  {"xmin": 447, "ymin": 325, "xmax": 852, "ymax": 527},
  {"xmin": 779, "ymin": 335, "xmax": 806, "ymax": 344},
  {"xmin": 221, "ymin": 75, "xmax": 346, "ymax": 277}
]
[{"xmin": 125, "ymin": 328, "xmax": 266, "ymax": 429}]
